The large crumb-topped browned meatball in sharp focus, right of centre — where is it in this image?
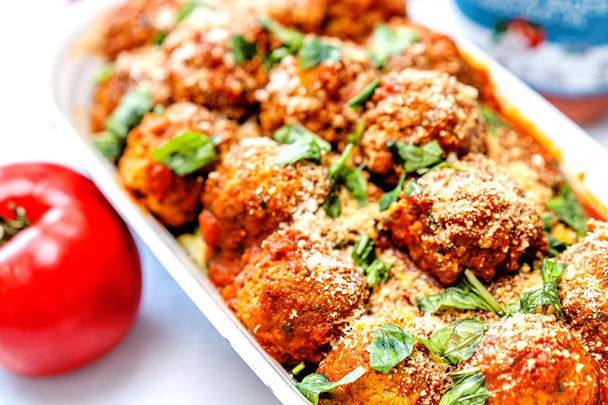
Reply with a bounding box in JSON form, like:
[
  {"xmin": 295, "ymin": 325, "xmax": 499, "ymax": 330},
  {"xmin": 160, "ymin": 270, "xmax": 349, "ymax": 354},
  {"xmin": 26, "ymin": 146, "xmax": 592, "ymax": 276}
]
[{"xmin": 385, "ymin": 155, "xmax": 547, "ymax": 284}]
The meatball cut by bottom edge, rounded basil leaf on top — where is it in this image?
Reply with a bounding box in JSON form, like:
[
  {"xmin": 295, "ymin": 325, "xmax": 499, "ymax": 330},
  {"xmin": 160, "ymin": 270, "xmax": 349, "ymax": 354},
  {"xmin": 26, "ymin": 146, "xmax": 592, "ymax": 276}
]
[{"xmin": 318, "ymin": 317, "xmax": 450, "ymax": 405}]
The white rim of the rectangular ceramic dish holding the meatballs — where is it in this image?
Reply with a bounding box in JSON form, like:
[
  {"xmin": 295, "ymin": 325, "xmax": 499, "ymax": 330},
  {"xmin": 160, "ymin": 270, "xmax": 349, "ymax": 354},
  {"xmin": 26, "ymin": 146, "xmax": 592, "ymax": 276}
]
[{"xmin": 48, "ymin": 0, "xmax": 608, "ymax": 404}]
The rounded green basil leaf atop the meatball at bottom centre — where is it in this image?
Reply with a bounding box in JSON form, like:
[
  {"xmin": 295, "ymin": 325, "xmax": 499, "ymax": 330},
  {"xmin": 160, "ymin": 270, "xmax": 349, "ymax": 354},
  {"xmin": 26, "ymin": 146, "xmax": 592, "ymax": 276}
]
[{"xmin": 367, "ymin": 323, "xmax": 414, "ymax": 374}]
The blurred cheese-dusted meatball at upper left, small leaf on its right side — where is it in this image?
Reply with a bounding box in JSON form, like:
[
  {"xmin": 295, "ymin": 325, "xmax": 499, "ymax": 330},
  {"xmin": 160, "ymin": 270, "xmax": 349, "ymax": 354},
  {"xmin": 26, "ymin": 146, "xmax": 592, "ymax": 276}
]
[{"xmin": 163, "ymin": 7, "xmax": 269, "ymax": 118}]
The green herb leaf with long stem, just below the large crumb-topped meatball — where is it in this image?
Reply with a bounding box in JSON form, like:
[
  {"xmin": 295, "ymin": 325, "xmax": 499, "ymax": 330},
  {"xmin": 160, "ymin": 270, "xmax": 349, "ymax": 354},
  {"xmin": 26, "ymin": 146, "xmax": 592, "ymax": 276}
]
[{"xmin": 416, "ymin": 270, "xmax": 509, "ymax": 316}]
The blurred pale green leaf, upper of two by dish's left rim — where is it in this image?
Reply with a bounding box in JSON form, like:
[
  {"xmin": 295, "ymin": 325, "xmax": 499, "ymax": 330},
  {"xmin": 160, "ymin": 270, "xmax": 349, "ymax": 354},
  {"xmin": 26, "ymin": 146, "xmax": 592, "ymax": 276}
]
[{"xmin": 105, "ymin": 90, "xmax": 154, "ymax": 139}]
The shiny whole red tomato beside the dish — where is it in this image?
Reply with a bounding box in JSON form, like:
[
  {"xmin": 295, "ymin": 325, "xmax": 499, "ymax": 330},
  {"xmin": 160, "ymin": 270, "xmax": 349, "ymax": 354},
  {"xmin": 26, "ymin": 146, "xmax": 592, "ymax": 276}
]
[{"xmin": 0, "ymin": 163, "xmax": 141, "ymax": 375}]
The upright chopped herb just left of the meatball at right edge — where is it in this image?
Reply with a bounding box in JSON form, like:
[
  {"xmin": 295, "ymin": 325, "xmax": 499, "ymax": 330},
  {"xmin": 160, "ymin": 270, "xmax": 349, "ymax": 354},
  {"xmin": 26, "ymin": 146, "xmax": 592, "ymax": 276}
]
[{"xmin": 519, "ymin": 258, "xmax": 567, "ymax": 315}]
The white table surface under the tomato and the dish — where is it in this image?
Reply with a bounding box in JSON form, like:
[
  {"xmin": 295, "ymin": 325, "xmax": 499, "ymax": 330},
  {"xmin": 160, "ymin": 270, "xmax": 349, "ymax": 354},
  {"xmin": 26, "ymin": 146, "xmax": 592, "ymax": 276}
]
[{"xmin": 0, "ymin": 0, "xmax": 608, "ymax": 405}]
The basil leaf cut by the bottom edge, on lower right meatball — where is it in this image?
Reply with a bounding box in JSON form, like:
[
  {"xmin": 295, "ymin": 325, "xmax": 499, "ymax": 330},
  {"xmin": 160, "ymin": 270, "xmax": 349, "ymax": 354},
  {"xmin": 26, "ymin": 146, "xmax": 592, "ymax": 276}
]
[{"xmin": 439, "ymin": 369, "xmax": 492, "ymax": 405}]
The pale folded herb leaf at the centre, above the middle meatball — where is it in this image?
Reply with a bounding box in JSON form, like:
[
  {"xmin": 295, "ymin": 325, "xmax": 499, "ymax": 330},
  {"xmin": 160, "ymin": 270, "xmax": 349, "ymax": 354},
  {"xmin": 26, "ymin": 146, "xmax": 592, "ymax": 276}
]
[{"xmin": 273, "ymin": 124, "xmax": 331, "ymax": 166}]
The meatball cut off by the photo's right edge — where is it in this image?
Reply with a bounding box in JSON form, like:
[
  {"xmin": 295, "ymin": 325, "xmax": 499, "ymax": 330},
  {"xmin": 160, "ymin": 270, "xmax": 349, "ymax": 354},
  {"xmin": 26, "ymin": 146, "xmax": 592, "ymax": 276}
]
[{"xmin": 558, "ymin": 220, "xmax": 608, "ymax": 368}]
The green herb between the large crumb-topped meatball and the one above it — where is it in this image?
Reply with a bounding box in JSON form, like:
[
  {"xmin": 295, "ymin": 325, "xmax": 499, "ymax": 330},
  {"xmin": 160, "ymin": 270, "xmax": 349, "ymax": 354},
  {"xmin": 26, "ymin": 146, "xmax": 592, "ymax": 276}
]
[{"xmin": 385, "ymin": 141, "xmax": 445, "ymax": 174}]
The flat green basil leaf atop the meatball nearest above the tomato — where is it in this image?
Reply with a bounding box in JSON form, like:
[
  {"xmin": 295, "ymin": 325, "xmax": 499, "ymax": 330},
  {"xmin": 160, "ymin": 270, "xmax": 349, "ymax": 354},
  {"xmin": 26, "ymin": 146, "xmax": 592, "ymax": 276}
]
[{"xmin": 152, "ymin": 131, "xmax": 217, "ymax": 176}]
